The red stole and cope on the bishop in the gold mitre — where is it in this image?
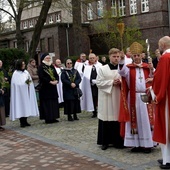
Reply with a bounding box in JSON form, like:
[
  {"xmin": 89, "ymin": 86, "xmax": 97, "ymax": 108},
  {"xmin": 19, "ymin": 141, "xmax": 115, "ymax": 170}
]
[{"xmin": 119, "ymin": 63, "xmax": 153, "ymax": 136}]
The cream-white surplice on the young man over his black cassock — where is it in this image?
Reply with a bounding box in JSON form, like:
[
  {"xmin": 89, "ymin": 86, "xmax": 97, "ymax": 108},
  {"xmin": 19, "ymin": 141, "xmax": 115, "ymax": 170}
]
[{"xmin": 96, "ymin": 64, "xmax": 121, "ymax": 121}]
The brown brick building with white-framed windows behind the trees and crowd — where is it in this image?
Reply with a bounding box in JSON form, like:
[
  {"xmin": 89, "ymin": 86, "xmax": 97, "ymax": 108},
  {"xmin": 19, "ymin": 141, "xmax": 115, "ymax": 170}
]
[{"xmin": 0, "ymin": 0, "xmax": 170, "ymax": 60}]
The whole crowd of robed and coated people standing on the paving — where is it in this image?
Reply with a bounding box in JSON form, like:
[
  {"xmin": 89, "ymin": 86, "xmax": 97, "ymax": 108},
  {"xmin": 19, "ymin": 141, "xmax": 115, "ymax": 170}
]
[{"xmin": 0, "ymin": 36, "xmax": 170, "ymax": 169}]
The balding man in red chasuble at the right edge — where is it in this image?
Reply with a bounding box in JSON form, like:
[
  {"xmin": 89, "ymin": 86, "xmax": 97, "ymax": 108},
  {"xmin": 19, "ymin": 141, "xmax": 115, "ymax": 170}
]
[{"xmin": 152, "ymin": 36, "xmax": 170, "ymax": 169}]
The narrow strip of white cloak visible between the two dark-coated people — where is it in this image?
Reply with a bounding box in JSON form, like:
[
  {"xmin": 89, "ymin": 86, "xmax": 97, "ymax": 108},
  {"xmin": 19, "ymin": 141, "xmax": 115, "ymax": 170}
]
[{"xmin": 55, "ymin": 67, "xmax": 64, "ymax": 103}]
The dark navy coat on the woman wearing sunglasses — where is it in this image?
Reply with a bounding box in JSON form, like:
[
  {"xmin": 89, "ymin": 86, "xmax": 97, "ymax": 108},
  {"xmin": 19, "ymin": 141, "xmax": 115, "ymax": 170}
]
[{"xmin": 61, "ymin": 68, "xmax": 81, "ymax": 100}]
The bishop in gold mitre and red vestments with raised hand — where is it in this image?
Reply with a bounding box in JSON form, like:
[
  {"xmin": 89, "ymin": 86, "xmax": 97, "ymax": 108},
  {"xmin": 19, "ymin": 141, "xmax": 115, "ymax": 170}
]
[{"xmin": 119, "ymin": 42, "xmax": 155, "ymax": 153}]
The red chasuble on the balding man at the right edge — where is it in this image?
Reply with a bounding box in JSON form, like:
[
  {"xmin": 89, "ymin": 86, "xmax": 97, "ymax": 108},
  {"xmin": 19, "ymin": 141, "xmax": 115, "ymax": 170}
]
[{"xmin": 152, "ymin": 53, "xmax": 170, "ymax": 144}]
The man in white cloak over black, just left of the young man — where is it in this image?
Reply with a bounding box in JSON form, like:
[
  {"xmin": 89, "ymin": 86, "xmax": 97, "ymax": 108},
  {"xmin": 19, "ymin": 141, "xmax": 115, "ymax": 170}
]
[{"xmin": 81, "ymin": 53, "xmax": 102, "ymax": 118}]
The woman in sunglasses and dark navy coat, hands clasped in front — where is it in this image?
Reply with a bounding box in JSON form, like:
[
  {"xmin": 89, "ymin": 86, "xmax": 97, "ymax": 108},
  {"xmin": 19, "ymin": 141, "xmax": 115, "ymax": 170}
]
[{"xmin": 61, "ymin": 59, "xmax": 81, "ymax": 121}]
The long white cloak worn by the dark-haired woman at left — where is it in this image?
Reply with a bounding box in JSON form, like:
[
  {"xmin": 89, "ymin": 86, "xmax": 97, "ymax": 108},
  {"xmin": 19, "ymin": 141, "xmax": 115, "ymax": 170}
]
[{"xmin": 10, "ymin": 70, "xmax": 39, "ymax": 121}]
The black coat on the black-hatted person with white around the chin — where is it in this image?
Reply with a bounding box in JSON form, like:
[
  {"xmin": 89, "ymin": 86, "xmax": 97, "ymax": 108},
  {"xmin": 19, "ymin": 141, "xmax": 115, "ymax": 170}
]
[{"xmin": 38, "ymin": 63, "xmax": 59, "ymax": 99}]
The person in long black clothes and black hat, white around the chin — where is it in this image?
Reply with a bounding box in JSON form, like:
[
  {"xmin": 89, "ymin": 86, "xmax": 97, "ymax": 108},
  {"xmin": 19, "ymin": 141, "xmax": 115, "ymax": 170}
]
[{"xmin": 38, "ymin": 53, "xmax": 60, "ymax": 124}]
